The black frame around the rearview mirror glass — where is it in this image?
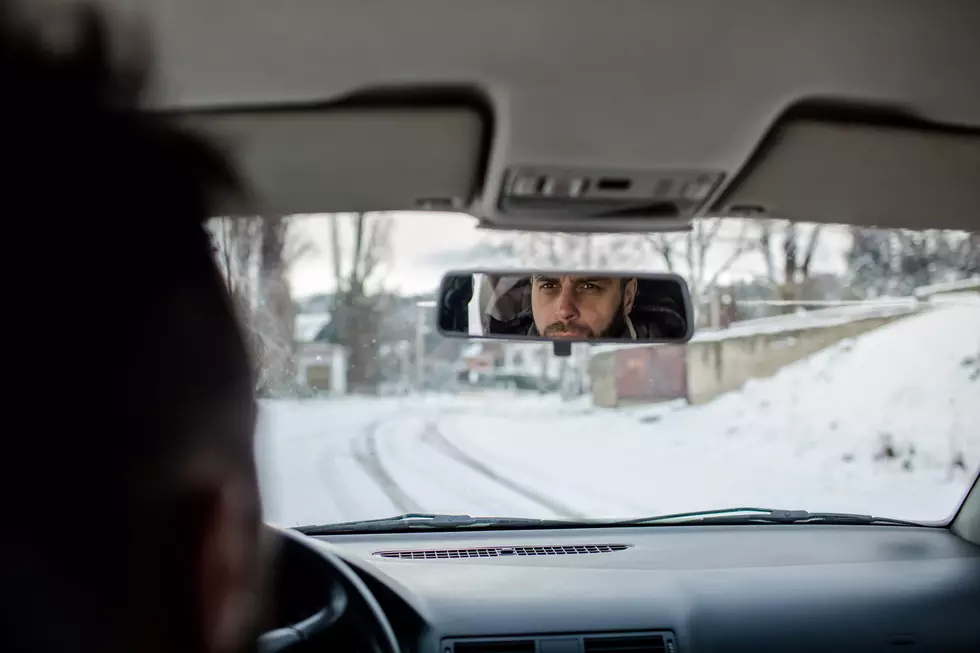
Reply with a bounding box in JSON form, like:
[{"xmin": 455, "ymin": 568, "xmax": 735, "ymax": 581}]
[{"xmin": 432, "ymin": 267, "xmax": 694, "ymax": 347}]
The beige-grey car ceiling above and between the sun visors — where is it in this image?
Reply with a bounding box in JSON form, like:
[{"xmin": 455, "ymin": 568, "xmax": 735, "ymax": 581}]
[{"xmin": 92, "ymin": 0, "xmax": 980, "ymax": 230}]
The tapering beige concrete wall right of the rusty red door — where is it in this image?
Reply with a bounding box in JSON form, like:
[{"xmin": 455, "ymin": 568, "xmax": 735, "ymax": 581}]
[{"xmin": 687, "ymin": 315, "xmax": 904, "ymax": 404}]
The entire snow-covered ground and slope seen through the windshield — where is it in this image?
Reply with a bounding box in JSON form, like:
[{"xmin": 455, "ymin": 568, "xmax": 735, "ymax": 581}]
[{"xmin": 259, "ymin": 304, "xmax": 980, "ymax": 526}]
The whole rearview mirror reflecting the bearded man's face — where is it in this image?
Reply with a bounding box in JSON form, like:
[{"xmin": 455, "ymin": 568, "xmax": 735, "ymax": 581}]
[{"xmin": 437, "ymin": 270, "xmax": 694, "ymax": 343}]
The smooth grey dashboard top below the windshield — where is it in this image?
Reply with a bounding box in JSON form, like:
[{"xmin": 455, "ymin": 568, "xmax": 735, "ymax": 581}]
[{"xmin": 318, "ymin": 524, "xmax": 980, "ymax": 653}]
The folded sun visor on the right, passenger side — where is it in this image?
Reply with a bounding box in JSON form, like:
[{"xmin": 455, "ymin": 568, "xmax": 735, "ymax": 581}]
[{"xmin": 712, "ymin": 109, "xmax": 980, "ymax": 231}]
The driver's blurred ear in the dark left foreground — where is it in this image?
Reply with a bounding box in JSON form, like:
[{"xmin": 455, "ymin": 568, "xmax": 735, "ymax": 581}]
[{"xmin": 196, "ymin": 473, "xmax": 260, "ymax": 653}]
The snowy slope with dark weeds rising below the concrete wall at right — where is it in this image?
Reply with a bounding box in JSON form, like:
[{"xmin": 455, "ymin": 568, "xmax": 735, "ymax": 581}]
[{"xmin": 705, "ymin": 305, "xmax": 980, "ymax": 472}]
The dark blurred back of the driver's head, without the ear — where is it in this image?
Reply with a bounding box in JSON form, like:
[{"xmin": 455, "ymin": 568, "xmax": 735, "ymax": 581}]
[{"xmin": 0, "ymin": 0, "xmax": 255, "ymax": 651}]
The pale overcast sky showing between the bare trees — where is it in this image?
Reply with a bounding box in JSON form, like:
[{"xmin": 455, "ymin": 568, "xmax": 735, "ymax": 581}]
[{"xmin": 290, "ymin": 212, "xmax": 850, "ymax": 297}]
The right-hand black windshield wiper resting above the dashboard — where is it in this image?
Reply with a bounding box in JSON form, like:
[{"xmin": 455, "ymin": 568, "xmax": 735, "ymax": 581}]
[{"xmin": 603, "ymin": 508, "xmax": 926, "ymax": 527}]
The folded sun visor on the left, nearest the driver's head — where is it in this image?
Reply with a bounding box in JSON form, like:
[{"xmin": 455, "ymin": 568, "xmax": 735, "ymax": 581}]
[{"xmin": 180, "ymin": 91, "xmax": 491, "ymax": 215}]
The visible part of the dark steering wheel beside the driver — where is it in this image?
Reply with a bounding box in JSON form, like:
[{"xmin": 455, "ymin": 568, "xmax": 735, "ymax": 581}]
[{"xmin": 257, "ymin": 527, "xmax": 400, "ymax": 653}]
